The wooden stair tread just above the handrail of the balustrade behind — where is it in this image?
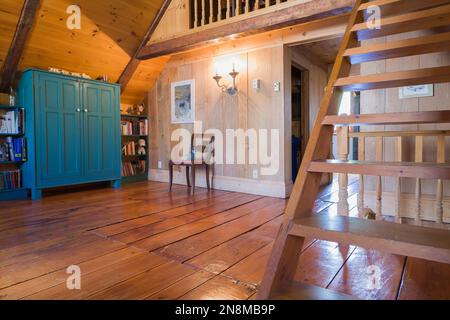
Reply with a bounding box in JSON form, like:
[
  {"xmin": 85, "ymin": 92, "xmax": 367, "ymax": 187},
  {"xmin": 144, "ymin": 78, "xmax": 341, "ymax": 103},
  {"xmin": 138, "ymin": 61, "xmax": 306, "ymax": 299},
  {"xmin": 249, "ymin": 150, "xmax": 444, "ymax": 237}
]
[{"xmin": 322, "ymin": 110, "xmax": 450, "ymax": 126}]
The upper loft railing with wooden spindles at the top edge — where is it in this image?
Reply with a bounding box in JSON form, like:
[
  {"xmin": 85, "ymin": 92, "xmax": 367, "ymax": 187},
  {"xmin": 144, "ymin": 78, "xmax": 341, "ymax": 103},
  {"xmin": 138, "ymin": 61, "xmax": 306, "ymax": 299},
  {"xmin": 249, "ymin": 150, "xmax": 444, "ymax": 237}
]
[{"xmin": 189, "ymin": 0, "xmax": 292, "ymax": 29}]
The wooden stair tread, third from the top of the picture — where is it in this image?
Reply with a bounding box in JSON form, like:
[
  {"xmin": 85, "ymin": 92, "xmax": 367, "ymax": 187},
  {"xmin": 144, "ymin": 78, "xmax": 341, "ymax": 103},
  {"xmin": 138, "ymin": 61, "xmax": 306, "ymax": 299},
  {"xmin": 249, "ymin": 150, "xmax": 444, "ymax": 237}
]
[{"xmin": 344, "ymin": 32, "xmax": 450, "ymax": 64}]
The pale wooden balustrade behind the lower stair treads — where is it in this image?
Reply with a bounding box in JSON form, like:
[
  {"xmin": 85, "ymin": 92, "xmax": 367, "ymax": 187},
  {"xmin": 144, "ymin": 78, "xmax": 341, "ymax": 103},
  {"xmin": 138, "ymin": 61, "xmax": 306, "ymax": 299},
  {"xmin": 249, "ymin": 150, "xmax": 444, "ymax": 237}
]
[{"xmin": 336, "ymin": 126, "xmax": 450, "ymax": 228}]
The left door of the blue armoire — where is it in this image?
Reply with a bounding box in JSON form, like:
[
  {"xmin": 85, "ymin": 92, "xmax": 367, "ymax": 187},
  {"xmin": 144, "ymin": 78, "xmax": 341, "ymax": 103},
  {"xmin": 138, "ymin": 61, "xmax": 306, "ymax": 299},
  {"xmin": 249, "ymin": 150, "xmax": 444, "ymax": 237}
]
[{"xmin": 36, "ymin": 75, "xmax": 82, "ymax": 187}]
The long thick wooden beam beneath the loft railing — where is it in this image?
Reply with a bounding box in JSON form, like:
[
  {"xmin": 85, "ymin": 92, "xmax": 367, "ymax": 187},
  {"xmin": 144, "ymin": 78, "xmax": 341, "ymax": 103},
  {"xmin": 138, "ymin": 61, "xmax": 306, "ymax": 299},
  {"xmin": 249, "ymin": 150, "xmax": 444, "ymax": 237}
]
[{"xmin": 137, "ymin": 0, "xmax": 355, "ymax": 60}]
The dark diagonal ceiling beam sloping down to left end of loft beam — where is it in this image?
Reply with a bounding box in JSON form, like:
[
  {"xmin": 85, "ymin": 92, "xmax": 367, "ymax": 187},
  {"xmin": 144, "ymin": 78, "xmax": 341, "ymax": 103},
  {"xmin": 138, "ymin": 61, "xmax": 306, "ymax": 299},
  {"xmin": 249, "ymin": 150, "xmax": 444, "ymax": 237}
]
[{"xmin": 117, "ymin": 0, "xmax": 171, "ymax": 92}]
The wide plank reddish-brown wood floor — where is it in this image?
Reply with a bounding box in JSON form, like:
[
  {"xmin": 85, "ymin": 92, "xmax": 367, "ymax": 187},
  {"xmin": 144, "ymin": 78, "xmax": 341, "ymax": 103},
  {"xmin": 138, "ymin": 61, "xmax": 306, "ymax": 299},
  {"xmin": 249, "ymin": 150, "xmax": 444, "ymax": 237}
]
[{"xmin": 0, "ymin": 181, "xmax": 450, "ymax": 300}]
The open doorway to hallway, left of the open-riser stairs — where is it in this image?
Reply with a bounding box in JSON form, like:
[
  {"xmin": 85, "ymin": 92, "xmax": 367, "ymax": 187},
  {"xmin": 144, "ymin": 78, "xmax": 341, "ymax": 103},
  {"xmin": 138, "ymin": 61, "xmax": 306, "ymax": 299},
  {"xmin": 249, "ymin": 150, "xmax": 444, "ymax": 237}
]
[{"xmin": 285, "ymin": 37, "xmax": 342, "ymax": 184}]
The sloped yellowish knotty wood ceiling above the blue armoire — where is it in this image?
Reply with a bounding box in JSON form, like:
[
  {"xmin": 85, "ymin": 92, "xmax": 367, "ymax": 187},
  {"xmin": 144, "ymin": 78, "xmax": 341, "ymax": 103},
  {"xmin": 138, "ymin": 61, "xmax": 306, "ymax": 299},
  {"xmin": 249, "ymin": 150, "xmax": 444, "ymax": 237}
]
[{"xmin": 0, "ymin": 0, "xmax": 167, "ymax": 104}]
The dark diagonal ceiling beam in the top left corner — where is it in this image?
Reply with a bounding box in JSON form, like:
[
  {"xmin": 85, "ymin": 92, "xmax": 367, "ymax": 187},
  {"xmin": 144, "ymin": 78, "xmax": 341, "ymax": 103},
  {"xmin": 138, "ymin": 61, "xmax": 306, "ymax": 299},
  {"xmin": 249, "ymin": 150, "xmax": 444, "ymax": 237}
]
[{"xmin": 0, "ymin": 0, "xmax": 41, "ymax": 92}]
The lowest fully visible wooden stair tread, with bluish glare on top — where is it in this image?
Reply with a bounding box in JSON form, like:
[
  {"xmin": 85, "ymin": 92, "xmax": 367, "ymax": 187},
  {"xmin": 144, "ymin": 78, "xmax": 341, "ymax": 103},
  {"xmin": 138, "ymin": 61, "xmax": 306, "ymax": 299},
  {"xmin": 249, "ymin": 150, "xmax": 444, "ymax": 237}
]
[{"xmin": 290, "ymin": 214, "xmax": 450, "ymax": 263}]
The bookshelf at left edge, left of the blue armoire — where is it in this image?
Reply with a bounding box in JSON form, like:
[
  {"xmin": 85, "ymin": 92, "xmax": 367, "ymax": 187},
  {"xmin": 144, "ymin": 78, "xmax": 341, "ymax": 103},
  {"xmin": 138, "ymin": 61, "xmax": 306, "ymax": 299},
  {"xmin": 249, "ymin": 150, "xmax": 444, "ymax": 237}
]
[{"xmin": 0, "ymin": 105, "xmax": 28, "ymax": 201}]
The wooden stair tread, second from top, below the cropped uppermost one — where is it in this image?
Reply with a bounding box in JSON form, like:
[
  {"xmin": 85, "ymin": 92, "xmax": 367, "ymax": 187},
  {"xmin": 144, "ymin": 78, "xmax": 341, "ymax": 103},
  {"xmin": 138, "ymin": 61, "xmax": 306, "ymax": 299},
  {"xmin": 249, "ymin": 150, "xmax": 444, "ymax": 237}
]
[{"xmin": 352, "ymin": 5, "xmax": 450, "ymax": 40}]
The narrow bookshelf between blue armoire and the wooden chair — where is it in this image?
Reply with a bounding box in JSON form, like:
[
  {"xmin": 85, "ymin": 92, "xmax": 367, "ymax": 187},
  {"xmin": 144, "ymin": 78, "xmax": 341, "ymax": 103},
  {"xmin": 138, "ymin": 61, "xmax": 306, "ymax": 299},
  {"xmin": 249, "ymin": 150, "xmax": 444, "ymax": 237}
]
[{"xmin": 120, "ymin": 114, "xmax": 149, "ymax": 183}]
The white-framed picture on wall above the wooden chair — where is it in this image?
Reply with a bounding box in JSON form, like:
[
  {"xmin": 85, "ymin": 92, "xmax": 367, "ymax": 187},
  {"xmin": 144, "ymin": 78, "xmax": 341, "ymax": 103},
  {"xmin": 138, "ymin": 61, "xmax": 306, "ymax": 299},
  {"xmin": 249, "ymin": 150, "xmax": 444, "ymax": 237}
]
[{"xmin": 171, "ymin": 80, "xmax": 195, "ymax": 123}]
